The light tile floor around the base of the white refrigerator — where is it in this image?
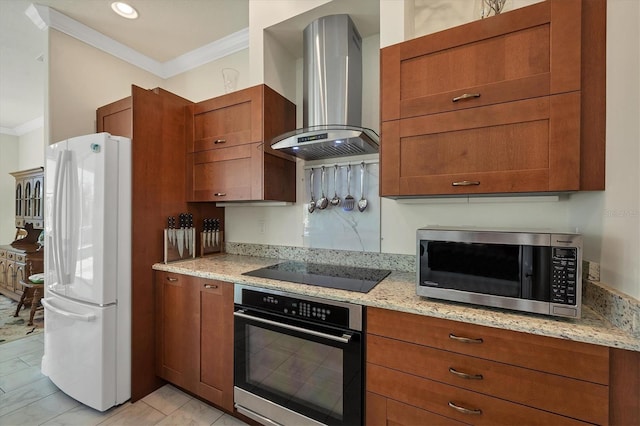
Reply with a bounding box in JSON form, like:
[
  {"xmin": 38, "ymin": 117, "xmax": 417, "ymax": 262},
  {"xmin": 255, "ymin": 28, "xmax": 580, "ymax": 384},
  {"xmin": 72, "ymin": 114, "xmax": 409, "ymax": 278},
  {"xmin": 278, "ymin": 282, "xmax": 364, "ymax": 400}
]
[{"xmin": 0, "ymin": 334, "xmax": 246, "ymax": 426}]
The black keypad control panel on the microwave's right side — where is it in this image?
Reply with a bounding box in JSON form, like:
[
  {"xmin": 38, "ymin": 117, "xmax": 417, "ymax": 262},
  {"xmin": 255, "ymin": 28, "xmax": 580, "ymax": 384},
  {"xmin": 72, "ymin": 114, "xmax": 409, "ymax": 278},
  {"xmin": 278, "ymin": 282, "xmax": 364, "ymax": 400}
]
[{"xmin": 551, "ymin": 247, "xmax": 580, "ymax": 305}]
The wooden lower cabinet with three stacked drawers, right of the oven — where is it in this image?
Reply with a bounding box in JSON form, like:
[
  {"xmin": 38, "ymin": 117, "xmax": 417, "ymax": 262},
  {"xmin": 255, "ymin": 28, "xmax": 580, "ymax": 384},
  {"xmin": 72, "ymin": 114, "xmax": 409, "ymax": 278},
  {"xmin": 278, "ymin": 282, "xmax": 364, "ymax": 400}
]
[{"xmin": 366, "ymin": 308, "xmax": 640, "ymax": 425}]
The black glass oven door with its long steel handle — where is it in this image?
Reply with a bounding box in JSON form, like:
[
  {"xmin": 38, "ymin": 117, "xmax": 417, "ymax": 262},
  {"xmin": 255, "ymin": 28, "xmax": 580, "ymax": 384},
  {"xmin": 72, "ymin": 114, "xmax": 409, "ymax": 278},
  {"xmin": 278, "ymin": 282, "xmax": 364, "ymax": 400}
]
[{"xmin": 234, "ymin": 310, "xmax": 363, "ymax": 425}]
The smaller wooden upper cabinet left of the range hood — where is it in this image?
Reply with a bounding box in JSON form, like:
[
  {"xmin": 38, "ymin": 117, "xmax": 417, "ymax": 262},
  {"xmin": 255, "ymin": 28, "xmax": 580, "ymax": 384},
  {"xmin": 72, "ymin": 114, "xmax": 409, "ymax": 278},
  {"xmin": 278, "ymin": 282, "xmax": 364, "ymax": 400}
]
[{"xmin": 187, "ymin": 85, "xmax": 296, "ymax": 202}]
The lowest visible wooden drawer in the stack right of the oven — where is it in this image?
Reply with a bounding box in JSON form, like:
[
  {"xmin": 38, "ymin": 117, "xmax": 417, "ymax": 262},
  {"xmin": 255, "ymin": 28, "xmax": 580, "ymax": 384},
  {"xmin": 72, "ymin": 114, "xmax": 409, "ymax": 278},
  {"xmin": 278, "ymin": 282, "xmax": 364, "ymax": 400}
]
[{"xmin": 366, "ymin": 363, "xmax": 584, "ymax": 425}]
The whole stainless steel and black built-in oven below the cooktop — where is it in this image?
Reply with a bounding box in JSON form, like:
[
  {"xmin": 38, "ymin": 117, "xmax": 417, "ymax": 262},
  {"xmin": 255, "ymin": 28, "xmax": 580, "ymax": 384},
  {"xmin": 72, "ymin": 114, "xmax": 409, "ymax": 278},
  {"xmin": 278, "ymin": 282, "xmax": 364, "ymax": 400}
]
[{"xmin": 234, "ymin": 284, "xmax": 364, "ymax": 425}]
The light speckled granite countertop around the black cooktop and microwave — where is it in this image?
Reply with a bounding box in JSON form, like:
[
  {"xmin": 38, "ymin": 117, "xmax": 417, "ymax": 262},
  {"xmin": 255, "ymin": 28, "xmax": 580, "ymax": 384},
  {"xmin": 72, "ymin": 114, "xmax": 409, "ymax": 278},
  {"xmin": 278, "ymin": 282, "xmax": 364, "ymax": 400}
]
[{"xmin": 153, "ymin": 254, "xmax": 640, "ymax": 351}]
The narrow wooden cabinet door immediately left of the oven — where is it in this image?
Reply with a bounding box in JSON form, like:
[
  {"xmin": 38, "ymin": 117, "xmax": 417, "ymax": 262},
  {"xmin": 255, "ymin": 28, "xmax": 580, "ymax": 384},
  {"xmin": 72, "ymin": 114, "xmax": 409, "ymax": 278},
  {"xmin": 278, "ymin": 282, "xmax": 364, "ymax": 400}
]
[{"xmin": 198, "ymin": 280, "xmax": 233, "ymax": 411}]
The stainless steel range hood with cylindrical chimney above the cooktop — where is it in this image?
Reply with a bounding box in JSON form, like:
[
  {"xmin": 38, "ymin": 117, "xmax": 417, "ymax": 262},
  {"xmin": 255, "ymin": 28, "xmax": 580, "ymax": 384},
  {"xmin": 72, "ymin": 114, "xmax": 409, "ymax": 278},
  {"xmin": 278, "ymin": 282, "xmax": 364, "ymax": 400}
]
[{"xmin": 271, "ymin": 15, "xmax": 379, "ymax": 160}]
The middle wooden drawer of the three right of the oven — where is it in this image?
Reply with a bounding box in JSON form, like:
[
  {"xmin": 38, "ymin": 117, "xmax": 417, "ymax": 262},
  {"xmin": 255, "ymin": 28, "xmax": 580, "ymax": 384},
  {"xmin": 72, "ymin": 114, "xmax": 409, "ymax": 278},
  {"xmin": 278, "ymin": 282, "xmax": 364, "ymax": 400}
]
[{"xmin": 367, "ymin": 335, "xmax": 609, "ymax": 424}]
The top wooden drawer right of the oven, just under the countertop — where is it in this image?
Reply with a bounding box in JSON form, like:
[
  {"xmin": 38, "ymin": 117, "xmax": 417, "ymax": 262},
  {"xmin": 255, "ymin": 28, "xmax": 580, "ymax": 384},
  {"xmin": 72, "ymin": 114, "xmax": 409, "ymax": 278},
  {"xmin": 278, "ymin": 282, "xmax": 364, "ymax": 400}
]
[{"xmin": 367, "ymin": 308, "xmax": 609, "ymax": 385}]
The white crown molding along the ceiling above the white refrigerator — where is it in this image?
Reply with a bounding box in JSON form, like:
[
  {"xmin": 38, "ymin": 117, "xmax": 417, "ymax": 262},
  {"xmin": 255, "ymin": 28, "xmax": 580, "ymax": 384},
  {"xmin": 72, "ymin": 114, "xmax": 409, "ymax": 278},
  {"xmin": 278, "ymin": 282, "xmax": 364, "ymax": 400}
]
[{"xmin": 25, "ymin": 4, "xmax": 249, "ymax": 79}]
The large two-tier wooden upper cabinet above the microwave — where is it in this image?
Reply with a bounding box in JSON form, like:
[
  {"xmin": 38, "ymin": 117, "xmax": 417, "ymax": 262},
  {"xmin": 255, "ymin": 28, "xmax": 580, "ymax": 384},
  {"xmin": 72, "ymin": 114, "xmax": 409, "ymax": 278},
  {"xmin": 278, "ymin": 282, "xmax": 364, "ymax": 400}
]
[{"xmin": 380, "ymin": 0, "xmax": 606, "ymax": 197}]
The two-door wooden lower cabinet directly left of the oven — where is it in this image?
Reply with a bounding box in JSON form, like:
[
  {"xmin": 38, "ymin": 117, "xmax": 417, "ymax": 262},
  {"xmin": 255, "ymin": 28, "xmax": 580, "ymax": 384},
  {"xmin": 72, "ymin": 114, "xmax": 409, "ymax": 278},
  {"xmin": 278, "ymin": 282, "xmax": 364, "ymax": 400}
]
[{"xmin": 155, "ymin": 271, "xmax": 233, "ymax": 412}]
